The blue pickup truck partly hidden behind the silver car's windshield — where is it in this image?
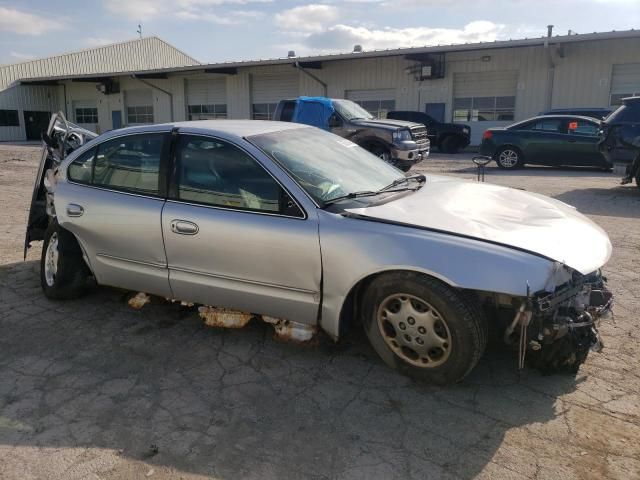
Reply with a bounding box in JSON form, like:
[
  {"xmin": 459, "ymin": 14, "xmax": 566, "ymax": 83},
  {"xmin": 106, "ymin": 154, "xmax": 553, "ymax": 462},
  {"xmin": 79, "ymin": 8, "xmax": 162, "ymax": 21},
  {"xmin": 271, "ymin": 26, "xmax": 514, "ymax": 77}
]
[{"xmin": 273, "ymin": 97, "xmax": 430, "ymax": 172}]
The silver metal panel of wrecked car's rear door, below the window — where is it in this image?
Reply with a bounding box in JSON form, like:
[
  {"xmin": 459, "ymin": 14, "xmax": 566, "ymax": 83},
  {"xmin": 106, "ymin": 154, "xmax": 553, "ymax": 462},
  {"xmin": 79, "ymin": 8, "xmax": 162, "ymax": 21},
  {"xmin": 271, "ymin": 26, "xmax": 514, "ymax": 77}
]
[{"xmin": 55, "ymin": 180, "xmax": 171, "ymax": 296}]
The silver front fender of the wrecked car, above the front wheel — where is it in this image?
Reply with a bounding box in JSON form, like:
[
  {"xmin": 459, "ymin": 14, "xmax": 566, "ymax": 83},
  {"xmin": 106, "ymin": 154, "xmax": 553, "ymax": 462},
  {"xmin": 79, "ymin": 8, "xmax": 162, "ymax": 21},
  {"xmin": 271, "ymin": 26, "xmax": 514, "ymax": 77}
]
[{"xmin": 319, "ymin": 211, "xmax": 554, "ymax": 337}]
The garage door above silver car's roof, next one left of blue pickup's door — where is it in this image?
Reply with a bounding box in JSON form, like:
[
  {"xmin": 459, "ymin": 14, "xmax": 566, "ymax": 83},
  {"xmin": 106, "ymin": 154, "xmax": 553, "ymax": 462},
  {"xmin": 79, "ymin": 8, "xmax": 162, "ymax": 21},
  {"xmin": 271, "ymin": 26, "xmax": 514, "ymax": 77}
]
[{"xmin": 186, "ymin": 78, "xmax": 227, "ymax": 120}]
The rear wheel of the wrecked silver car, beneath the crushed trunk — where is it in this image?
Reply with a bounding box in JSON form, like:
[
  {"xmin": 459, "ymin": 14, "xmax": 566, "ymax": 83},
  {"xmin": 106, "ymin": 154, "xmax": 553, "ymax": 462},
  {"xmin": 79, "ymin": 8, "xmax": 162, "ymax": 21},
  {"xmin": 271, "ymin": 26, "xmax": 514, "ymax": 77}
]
[{"xmin": 40, "ymin": 221, "xmax": 89, "ymax": 300}]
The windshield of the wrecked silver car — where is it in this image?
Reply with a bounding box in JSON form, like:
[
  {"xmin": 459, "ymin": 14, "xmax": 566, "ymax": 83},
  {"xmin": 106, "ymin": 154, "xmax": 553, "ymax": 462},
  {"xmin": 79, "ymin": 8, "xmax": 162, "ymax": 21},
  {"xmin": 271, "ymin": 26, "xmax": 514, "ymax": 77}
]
[{"xmin": 247, "ymin": 128, "xmax": 404, "ymax": 205}]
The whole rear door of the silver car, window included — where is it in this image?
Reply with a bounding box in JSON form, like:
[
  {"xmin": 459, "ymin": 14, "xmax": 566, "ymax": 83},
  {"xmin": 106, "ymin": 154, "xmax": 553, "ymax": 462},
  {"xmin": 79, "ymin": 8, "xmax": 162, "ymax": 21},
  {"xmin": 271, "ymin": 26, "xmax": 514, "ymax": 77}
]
[{"xmin": 55, "ymin": 132, "xmax": 171, "ymax": 296}]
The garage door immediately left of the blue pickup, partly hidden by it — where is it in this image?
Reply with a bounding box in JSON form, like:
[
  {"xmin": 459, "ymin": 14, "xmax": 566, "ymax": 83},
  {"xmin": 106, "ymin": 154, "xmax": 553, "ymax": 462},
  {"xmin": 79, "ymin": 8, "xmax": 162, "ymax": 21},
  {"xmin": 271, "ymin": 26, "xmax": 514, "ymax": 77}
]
[{"xmin": 251, "ymin": 73, "xmax": 300, "ymax": 120}]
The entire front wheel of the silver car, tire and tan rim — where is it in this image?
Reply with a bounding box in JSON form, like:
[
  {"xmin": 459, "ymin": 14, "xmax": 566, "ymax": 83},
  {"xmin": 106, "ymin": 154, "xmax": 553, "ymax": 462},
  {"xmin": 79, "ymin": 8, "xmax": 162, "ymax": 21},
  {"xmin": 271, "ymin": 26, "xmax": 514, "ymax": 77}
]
[{"xmin": 363, "ymin": 272, "xmax": 488, "ymax": 385}]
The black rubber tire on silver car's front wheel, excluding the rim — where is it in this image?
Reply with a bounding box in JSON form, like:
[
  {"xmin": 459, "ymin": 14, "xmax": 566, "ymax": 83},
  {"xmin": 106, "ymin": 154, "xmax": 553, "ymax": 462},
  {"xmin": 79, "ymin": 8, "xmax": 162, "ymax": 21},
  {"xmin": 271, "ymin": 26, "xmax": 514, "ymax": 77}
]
[{"xmin": 362, "ymin": 272, "xmax": 488, "ymax": 385}]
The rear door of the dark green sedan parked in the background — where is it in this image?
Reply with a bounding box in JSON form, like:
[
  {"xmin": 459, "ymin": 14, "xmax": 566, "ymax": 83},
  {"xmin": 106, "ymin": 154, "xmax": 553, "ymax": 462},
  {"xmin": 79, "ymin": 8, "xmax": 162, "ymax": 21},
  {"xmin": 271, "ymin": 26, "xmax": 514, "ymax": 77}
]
[{"xmin": 562, "ymin": 118, "xmax": 604, "ymax": 166}]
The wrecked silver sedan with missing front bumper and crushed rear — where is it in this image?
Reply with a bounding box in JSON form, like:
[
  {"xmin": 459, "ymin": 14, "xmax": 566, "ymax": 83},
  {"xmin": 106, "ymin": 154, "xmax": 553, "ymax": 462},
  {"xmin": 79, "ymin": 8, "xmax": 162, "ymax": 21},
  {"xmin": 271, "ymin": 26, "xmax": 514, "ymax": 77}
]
[{"xmin": 25, "ymin": 114, "xmax": 612, "ymax": 384}]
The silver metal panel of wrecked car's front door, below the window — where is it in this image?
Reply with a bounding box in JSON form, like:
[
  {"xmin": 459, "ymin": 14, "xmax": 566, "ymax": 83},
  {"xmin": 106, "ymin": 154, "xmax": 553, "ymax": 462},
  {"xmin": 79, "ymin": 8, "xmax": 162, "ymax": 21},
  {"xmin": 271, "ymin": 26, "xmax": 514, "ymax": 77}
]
[{"xmin": 162, "ymin": 201, "xmax": 322, "ymax": 324}]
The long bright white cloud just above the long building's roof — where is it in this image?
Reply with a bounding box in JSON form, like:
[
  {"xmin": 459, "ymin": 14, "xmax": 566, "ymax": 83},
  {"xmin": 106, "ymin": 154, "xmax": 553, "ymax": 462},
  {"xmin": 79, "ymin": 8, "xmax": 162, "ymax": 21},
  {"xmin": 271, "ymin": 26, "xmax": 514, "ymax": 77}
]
[{"xmin": 305, "ymin": 20, "xmax": 504, "ymax": 51}]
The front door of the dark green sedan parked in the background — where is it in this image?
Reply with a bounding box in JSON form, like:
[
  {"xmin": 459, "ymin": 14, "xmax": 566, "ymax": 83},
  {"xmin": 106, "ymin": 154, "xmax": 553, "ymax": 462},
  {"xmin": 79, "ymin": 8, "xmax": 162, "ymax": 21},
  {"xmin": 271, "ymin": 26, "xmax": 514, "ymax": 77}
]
[{"xmin": 518, "ymin": 117, "xmax": 566, "ymax": 165}]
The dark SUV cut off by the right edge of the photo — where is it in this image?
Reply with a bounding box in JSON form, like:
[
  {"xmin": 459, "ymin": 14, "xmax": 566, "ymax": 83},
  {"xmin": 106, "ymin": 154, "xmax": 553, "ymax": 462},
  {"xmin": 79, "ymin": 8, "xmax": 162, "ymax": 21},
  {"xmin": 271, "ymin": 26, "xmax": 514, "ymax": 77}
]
[{"xmin": 599, "ymin": 97, "xmax": 640, "ymax": 188}]
